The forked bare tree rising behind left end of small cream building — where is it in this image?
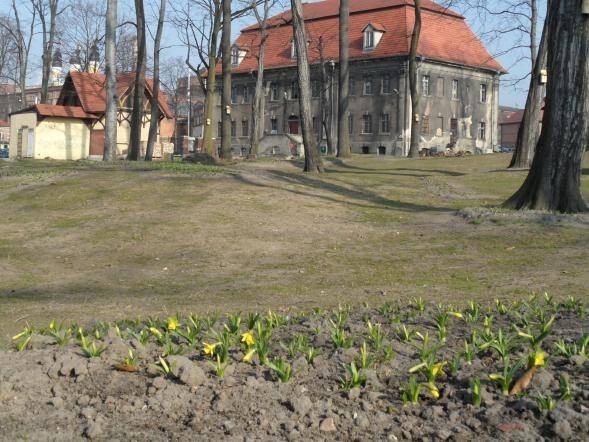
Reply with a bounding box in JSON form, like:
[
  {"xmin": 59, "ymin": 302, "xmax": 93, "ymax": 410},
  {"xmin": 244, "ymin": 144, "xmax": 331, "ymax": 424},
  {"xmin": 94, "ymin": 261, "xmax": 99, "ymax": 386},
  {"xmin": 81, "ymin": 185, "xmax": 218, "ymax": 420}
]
[{"xmin": 31, "ymin": 0, "xmax": 67, "ymax": 103}]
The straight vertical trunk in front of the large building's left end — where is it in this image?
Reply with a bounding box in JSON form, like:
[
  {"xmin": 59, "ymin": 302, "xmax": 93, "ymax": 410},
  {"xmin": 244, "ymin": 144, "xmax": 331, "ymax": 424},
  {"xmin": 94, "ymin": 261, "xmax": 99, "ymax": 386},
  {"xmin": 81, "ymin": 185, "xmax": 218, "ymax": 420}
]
[{"xmin": 221, "ymin": 0, "xmax": 232, "ymax": 160}]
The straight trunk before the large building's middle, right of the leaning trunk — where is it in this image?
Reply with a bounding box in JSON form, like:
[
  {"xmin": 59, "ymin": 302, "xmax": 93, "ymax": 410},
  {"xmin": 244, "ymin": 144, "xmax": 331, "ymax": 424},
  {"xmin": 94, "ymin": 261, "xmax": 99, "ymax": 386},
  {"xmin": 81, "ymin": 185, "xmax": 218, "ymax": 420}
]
[{"xmin": 337, "ymin": 0, "xmax": 352, "ymax": 158}]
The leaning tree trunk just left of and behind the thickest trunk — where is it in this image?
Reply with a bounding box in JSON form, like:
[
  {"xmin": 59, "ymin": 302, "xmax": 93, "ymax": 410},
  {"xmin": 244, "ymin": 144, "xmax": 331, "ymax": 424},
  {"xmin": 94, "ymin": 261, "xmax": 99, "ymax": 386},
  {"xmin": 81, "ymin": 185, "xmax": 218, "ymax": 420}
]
[{"xmin": 509, "ymin": 8, "xmax": 548, "ymax": 169}]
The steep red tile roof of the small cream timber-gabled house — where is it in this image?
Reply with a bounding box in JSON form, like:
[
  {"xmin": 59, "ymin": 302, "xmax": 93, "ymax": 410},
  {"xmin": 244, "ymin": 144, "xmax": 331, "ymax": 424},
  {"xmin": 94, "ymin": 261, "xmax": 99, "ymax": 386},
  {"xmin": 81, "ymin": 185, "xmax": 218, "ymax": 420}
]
[{"xmin": 69, "ymin": 72, "xmax": 172, "ymax": 118}]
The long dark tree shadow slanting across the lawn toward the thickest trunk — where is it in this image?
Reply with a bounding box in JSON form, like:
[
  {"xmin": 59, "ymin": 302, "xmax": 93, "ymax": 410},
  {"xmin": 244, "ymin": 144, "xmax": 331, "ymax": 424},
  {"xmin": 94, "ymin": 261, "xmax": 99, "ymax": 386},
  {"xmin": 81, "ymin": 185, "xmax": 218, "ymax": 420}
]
[{"xmin": 234, "ymin": 170, "xmax": 454, "ymax": 212}]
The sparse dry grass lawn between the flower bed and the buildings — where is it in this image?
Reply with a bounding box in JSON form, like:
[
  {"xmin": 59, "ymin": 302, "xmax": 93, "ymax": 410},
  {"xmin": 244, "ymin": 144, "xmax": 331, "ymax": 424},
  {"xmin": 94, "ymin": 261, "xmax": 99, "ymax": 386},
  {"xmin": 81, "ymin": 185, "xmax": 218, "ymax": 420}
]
[{"xmin": 0, "ymin": 154, "xmax": 589, "ymax": 344}]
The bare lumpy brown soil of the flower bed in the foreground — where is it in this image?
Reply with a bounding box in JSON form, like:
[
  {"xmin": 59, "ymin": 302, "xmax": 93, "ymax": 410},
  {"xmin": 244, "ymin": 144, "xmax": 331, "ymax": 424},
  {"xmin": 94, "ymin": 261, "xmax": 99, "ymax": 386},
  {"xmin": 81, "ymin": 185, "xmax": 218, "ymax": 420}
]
[{"xmin": 0, "ymin": 296, "xmax": 589, "ymax": 441}]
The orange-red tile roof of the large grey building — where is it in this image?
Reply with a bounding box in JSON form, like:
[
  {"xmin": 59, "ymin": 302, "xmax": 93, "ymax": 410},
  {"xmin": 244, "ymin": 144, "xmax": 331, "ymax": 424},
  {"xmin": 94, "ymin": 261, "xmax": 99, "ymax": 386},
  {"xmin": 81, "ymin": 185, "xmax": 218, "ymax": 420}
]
[{"xmin": 227, "ymin": 0, "xmax": 506, "ymax": 73}]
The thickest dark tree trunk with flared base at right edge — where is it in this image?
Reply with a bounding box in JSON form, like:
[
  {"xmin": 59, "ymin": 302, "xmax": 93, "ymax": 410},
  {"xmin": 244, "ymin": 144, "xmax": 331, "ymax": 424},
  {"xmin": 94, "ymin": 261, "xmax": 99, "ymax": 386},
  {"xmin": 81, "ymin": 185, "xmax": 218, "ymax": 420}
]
[{"xmin": 504, "ymin": 0, "xmax": 589, "ymax": 213}]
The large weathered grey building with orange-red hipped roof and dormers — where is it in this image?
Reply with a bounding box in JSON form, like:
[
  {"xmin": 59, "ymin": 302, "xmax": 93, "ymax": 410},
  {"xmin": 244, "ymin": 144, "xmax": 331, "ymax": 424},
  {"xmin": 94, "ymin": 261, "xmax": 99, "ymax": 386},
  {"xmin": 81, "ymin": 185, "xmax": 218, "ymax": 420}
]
[{"xmin": 210, "ymin": 0, "xmax": 505, "ymax": 156}]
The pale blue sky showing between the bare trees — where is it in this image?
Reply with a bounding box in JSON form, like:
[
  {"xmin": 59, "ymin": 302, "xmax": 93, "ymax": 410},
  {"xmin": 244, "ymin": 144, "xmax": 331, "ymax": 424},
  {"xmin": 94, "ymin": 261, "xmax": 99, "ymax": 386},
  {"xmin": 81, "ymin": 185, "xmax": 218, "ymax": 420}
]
[{"xmin": 0, "ymin": 0, "xmax": 545, "ymax": 107}]
